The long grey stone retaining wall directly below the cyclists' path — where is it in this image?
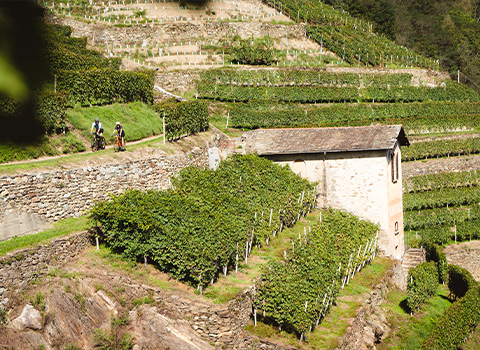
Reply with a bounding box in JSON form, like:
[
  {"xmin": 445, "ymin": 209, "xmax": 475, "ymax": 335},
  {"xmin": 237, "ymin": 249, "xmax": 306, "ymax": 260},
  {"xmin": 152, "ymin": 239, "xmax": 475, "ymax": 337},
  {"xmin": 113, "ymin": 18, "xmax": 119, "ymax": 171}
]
[{"xmin": 0, "ymin": 148, "xmax": 208, "ymax": 224}]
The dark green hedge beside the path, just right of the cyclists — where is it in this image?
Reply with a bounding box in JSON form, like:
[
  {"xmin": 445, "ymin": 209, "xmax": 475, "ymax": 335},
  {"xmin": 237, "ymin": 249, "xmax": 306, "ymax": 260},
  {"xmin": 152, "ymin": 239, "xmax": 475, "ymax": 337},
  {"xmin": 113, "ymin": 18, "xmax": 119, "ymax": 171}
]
[{"xmin": 154, "ymin": 99, "xmax": 209, "ymax": 139}]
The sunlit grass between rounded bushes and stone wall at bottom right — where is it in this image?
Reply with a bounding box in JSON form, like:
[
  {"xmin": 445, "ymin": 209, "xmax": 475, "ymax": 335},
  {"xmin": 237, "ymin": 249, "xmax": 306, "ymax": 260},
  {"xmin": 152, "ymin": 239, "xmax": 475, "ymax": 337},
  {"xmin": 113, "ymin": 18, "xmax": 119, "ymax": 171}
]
[{"xmin": 377, "ymin": 286, "xmax": 452, "ymax": 350}]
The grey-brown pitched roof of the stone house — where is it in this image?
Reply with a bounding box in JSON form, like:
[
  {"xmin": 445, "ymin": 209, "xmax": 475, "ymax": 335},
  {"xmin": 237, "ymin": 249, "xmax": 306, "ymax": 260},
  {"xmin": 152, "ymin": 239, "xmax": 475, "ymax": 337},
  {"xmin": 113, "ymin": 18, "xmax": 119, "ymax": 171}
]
[{"xmin": 243, "ymin": 125, "xmax": 410, "ymax": 155}]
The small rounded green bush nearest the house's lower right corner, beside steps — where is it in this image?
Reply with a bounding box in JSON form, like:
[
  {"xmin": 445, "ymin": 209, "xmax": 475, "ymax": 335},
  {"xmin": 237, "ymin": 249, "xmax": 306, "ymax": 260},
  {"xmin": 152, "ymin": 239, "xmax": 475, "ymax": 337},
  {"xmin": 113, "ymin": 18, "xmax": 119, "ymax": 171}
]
[{"xmin": 407, "ymin": 261, "xmax": 438, "ymax": 311}]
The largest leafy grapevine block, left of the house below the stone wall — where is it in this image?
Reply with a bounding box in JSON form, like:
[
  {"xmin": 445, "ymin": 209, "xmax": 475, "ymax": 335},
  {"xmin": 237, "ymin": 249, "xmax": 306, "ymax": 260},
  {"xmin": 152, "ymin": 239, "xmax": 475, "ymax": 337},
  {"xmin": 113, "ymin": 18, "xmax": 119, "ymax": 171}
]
[{"xmin": 91, "ymin": 155, "xmax": 315, "ymax": 290}]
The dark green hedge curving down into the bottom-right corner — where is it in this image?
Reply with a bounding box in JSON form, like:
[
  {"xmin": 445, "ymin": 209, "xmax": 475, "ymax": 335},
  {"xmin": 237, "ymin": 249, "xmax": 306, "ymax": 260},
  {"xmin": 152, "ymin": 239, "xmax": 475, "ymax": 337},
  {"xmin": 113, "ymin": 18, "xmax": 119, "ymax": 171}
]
[{"xmin": 421, "ymin": 265, "xmax": 480, "ymax": 350}]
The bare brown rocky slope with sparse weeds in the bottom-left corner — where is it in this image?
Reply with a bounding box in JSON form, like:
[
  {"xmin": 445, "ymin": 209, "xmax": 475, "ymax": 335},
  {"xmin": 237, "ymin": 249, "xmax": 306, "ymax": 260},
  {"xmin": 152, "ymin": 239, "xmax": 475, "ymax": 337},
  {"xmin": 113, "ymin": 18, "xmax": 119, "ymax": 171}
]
[{"xmin": 0, "ymin": 249, "xmax": 213, "ymax": 350}]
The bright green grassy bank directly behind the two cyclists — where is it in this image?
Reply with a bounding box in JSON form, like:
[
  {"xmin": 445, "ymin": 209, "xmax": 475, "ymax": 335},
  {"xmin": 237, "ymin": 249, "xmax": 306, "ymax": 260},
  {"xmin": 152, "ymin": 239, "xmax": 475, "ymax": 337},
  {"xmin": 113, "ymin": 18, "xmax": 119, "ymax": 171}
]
[{"xmin": 67, "ymin": 102, "xmax": 163, "ymax": 143}]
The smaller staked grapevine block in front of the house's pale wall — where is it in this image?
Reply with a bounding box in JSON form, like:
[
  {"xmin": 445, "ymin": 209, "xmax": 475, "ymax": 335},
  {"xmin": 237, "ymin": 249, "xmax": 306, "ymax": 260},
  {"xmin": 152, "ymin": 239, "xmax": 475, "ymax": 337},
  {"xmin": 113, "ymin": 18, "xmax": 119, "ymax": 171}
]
[{"xmin": 254, "ymin": 209, "xmax": 377, "ymax": 340}]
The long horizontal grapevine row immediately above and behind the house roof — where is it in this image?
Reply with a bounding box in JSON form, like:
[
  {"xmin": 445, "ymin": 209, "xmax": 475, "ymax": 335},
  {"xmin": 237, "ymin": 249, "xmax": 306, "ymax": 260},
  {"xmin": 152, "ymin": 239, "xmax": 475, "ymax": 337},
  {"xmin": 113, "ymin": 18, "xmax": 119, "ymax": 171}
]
[{"xmin": 223, "ymin": 101, "xmax": 480, "ymax": 132}]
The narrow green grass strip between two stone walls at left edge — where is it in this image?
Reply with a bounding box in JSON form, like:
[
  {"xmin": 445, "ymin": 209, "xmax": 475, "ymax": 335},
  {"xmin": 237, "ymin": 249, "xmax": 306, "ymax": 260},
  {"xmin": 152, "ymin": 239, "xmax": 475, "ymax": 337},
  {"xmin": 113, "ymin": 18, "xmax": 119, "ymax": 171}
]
[{"xmin": 0, "ymin": 216, "xmax": 89, "ymax": 256}]
